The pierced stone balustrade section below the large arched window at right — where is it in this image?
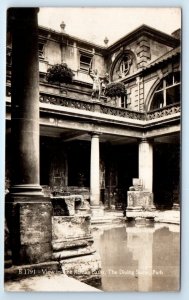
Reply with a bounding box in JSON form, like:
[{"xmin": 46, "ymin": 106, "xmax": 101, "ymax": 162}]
[{"xmin": 146, "ymin": 102, "xmax": 181, "ymax": 120}]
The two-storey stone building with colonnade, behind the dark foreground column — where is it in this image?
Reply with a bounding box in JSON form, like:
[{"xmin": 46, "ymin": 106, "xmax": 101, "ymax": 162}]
[{"xmin": 6, "ymin": 21, "xmax": 181, "ymax": 209}]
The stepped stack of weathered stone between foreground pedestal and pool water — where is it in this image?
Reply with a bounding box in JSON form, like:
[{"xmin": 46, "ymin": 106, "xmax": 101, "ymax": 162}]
[{"xmin": 52, "ymin": 215, "xmax": 101, "ymax": 283}]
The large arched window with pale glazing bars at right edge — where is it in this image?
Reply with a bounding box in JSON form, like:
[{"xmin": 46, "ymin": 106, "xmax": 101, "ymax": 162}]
[{"xmin": 150, "ymin": 72, "xmax": 180, "ymax": 110}]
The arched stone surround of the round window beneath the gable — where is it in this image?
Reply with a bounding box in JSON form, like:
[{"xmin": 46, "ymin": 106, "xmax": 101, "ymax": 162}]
[{"xmin": 110, "ymin": 49, "xmax": 136, "ymax": 81}]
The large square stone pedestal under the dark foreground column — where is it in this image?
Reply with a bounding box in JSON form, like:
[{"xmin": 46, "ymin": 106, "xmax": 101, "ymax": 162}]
[{"xmin": 5, "ymin": 196, "xmax": 52, "ymax": 265}]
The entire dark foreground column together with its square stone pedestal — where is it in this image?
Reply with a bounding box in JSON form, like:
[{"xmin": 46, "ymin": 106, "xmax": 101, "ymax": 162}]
[{"xmin": 6, "ymin": 8, "xmax": 52, "ymax": 265}]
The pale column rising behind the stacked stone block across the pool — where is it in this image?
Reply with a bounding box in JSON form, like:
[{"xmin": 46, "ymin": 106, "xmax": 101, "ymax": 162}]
[{"xmin": 139, "ymin": 139, "xmax": 153, "ymax": 192}]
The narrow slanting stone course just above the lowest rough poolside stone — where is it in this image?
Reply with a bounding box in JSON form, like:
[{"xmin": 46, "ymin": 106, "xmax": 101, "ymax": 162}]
[{"xmin": 53, "ymin": 246, "xmax": 96, "ymax": 259}]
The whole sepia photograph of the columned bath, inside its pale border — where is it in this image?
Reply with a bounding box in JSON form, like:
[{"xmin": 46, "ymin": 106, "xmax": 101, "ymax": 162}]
[{"xmin": 3, "ymin": 7, "xmax": 182, "ymax": 292}]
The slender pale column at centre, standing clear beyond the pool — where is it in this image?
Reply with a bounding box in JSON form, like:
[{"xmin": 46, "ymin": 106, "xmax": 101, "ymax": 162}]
[{"xmin": 90, "ymin": 133, "xmax": 103, "ymax": 215}]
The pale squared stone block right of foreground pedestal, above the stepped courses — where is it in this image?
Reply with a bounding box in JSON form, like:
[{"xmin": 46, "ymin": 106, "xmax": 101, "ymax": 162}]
[{"xmin": 52, "ymin": 215, "xmax": 91, "ymax": 241}]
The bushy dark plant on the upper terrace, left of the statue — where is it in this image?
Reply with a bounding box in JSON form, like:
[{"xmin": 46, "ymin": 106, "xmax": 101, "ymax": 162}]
[{"xmin": 47, "ymin": 63, "xmax": 74, "ymax": 83}]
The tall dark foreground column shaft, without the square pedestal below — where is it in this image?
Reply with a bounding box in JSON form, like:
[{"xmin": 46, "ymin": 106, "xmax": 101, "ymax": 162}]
[{"xmin": 11, "ymin": 8, "xmax": 42, "ymax": 195}]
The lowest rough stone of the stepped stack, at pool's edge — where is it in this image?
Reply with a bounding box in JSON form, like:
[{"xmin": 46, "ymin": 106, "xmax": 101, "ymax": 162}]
[{"xmin": 60, "ymin": 252, "xmax": 101, "ymax": 281}]
